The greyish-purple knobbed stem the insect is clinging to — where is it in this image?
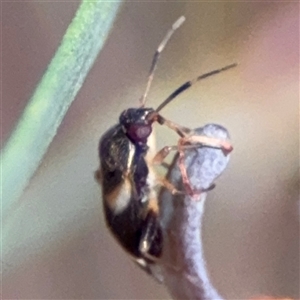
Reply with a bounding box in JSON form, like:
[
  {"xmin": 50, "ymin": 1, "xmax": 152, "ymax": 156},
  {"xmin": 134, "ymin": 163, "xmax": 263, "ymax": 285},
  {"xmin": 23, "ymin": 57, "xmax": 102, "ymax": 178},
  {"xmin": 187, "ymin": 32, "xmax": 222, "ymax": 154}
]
[{"xmin": 160, "ymin": 124, "xmax": 229, "ymax": 300}]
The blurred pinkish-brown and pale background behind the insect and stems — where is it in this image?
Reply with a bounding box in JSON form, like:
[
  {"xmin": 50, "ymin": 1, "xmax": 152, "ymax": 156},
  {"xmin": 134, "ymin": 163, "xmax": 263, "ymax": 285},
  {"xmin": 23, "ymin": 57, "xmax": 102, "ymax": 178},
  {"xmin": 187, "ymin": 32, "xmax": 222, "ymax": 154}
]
[{"xmin": 1, "ymin": 1, "xmax": 300, "ymax": 299}]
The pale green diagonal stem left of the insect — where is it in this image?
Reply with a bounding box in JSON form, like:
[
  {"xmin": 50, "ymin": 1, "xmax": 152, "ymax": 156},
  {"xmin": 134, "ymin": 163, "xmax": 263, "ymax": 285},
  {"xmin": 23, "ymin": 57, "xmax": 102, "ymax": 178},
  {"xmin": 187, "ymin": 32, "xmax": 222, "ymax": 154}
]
[{"xmin": 1, "ymin": 0, "xmax": 121, "ymax": 217}]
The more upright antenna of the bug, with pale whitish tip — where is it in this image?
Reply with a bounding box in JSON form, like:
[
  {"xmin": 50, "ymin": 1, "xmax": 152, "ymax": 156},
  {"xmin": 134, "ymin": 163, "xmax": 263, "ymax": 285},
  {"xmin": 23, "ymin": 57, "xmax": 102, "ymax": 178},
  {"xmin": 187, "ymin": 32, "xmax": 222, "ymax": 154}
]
[{"xmin": 140, "ymin": 16, "xmax": 185, "ymax": 107}]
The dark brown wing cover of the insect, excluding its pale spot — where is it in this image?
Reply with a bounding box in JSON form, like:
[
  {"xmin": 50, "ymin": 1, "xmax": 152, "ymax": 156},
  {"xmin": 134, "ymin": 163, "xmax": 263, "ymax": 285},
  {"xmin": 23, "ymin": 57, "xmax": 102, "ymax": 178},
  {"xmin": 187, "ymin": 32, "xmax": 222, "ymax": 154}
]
[{"xmin": 99, "ymin": 125, "xmax": 145, "ymax": 257}]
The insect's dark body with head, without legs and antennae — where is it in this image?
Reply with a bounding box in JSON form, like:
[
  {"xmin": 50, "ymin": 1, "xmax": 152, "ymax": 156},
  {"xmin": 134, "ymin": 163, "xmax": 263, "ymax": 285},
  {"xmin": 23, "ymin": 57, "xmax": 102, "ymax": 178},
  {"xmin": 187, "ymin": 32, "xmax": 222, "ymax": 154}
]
[{"xmin": 98, "ymin": 108, "xmax": 162, "ymax": 272}]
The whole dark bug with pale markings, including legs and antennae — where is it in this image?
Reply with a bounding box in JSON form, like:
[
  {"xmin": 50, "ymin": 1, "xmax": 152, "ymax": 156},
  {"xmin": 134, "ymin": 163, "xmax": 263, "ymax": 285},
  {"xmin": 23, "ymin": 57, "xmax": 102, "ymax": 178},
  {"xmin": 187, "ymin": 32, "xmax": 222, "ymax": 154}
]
[{"xmin": 95, "ymin": 16, "xmax": 235, "ymax": 274}]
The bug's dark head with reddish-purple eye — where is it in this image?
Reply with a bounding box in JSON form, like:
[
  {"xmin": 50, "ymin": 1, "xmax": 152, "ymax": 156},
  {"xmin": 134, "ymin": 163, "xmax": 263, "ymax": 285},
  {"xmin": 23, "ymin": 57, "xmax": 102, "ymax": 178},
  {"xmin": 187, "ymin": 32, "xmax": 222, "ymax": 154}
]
[{"xmin": 120, "ymin": 108, "xmax": 155, "ymax": 144}]
